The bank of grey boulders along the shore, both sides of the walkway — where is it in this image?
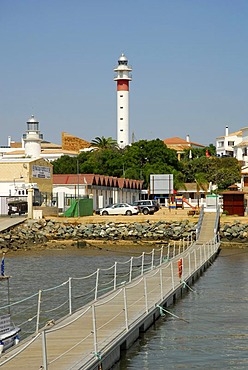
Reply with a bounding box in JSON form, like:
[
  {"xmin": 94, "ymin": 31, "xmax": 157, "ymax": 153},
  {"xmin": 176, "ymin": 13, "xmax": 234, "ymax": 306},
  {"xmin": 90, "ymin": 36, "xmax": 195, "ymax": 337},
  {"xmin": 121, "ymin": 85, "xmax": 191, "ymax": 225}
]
[{"xmin": 0, "ymin": 219, "xmax": 248, "ymax": 251}]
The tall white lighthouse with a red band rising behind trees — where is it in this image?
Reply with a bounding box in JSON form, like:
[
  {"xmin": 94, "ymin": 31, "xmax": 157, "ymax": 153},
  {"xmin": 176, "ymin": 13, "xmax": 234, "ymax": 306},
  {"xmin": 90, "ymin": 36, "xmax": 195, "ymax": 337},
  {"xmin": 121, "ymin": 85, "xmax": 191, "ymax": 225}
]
[{"xmin": 114, "ymin": 53, "xmax": 132, "ymax": 148}]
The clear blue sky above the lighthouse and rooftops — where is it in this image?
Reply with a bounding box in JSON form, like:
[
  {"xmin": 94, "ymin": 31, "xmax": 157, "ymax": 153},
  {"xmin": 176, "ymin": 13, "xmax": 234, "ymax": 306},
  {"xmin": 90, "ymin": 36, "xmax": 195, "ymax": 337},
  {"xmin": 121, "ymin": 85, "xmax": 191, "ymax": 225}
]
[{"xmin": 0, "ymin": 0, "xmax": 248, "ymax": 145}]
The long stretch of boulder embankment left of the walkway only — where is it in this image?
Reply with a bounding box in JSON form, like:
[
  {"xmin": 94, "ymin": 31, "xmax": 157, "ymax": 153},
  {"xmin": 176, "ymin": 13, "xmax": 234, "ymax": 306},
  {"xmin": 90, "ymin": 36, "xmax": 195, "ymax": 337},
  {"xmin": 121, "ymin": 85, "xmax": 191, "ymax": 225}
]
[{"xmin": 0, "ymin": 219, "xmax": 197, "ymax": 250}]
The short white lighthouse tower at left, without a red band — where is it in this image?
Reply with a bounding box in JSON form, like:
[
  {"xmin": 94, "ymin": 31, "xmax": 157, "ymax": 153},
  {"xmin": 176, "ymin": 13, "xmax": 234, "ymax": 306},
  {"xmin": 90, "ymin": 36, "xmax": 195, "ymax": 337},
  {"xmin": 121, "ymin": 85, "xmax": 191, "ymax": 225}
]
[{"xmin": 23, "ymin": 116, "xmax": 43, "ymax": 158}]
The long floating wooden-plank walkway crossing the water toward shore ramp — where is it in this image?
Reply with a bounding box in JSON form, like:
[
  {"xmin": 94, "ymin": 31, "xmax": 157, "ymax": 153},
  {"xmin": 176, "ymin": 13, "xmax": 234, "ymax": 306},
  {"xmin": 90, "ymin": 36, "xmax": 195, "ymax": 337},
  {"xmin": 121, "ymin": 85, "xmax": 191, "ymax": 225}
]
[{"xmin": 0, "ymin": 211, "xmax": 218, "ymax": 370}]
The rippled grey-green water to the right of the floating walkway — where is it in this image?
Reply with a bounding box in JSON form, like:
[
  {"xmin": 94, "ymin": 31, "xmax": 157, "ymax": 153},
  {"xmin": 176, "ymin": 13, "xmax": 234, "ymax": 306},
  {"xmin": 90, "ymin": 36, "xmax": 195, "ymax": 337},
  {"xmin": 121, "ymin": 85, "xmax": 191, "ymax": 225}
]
[{"xmin": 115, "ymin": 249, "xmax": 248, "ymax": 370}]
